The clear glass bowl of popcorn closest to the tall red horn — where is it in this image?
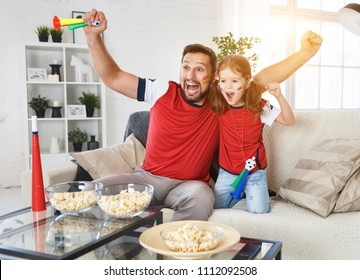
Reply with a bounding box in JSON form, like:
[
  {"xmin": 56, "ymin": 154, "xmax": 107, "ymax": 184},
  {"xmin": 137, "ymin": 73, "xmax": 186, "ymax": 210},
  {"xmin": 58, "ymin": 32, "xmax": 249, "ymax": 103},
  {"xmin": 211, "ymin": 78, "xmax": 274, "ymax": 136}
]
[{"xmin": 45, "ymin": 181, "xmax": 102, "ymax": 213}]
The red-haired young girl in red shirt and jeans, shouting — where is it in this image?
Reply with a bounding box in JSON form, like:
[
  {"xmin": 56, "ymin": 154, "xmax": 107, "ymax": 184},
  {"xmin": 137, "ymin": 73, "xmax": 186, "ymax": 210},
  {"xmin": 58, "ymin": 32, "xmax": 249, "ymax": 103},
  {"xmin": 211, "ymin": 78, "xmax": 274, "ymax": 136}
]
[{"xmin": 209, "ymin": 55, "xmax": 295, "ymax": 213}]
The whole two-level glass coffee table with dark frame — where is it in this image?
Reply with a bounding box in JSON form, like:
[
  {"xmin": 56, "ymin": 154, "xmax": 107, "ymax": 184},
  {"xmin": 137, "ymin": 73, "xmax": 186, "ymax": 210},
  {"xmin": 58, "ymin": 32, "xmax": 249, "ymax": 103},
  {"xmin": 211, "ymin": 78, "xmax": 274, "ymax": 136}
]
[{"xmin": 0, "ymin": 205, "xmax": 282, "ymax": 260}]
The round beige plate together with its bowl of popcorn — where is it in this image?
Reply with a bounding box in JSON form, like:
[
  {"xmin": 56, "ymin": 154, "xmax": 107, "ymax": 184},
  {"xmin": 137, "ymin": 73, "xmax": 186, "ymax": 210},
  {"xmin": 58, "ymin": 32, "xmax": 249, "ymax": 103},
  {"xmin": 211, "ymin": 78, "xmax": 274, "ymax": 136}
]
[{"xmin": 139, "ymin": 221, "xmax": 240, "ymax": 259}]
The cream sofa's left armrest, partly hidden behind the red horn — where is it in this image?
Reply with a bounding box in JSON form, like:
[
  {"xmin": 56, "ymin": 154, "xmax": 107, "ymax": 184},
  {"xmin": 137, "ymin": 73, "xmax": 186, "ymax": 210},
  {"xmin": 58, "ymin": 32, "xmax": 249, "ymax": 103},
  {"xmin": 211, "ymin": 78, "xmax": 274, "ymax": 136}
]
[{"xmin": 21, "ymin": 163, "xmax": 77, "ymax": 207}]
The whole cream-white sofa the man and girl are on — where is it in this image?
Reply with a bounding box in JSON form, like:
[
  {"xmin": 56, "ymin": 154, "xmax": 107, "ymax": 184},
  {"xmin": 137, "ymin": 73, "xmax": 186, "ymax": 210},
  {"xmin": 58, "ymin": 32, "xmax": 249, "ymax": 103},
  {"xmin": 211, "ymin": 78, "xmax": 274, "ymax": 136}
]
[{"xmin": 22, "ymin": 110, "xmax": 360, "ymax": 260}]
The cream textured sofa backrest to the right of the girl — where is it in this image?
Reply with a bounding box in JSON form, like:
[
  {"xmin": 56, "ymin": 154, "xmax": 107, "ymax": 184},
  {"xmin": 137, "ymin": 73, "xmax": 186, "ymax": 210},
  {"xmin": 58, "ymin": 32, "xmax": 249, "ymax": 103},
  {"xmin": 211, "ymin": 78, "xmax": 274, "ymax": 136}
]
[{"xmin": 263, "ymin": 109, "xmax": 360, "ymax": 192}]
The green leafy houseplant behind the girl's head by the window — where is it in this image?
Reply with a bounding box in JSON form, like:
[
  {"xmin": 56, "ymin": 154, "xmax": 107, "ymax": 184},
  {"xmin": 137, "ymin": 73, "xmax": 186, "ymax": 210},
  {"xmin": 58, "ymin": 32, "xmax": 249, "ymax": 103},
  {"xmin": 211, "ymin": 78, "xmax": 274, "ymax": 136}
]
[{"xmin": 212, "ymin": 32, "xmax": 261, "ymax": 69}]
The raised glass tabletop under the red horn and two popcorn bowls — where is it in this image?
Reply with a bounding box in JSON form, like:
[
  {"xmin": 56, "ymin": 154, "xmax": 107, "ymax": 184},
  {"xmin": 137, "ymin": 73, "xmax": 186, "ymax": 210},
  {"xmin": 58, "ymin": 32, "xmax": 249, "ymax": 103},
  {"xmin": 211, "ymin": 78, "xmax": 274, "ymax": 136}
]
[{"xmin": 0, "ymin": 205, "xmax": 162, "ymax": 259}]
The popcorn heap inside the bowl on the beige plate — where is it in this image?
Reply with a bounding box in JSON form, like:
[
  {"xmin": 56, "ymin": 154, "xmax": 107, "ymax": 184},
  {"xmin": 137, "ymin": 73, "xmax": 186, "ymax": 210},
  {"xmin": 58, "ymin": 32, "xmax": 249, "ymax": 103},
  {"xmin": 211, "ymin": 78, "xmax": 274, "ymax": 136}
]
[{"xmin": 163, "ymin": 224, "xmax": 219, "ymax": 253}]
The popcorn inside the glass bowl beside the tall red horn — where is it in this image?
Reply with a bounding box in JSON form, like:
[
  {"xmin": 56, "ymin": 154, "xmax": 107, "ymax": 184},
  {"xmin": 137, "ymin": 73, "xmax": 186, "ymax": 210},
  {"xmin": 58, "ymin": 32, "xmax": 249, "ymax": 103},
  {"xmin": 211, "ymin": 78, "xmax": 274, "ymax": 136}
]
[{"xmin": 50, "ymin": 191, "xmax": 98, "ymax": 211}]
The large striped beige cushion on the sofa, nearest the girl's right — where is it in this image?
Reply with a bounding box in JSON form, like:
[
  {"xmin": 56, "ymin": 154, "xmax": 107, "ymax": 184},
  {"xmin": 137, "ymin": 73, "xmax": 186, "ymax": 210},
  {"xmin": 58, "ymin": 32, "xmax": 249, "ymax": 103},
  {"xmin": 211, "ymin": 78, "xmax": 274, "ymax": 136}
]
[{"xmin": 279, "ymin": 139, "xmax": 360, "ymax": 217}]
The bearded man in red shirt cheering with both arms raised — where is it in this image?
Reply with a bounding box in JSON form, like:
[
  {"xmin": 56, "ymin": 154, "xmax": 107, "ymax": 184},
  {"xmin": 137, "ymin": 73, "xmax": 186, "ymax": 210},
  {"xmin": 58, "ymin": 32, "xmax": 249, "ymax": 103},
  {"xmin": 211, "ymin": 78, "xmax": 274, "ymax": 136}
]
[{"xmin": 83, "ymin": 9, "xmax": 322, "ymax": 220}]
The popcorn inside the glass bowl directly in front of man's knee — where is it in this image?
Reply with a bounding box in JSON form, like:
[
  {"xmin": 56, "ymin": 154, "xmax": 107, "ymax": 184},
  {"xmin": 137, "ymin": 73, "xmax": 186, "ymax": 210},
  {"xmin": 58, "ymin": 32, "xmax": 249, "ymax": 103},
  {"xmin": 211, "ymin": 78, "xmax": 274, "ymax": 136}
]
[{"xmin": 98, "ymin": 189, "xmax": 151, "ymax": 217}]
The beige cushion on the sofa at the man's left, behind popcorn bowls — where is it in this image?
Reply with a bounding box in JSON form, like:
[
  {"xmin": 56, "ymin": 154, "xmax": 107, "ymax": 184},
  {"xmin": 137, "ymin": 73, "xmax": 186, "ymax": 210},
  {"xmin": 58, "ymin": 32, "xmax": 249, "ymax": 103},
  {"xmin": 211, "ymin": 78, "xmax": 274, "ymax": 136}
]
[{"xmin": 71, "ymin": 134, "xmax": 145, "ymax": 180}]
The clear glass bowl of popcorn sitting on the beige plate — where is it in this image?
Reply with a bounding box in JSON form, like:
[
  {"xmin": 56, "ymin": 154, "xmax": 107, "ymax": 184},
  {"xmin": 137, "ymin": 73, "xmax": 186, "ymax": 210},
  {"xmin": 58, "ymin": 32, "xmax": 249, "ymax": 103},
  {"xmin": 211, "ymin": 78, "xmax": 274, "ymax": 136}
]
[{"xmin": 160, "ymin": 222, "xmax": 224, "ymax": 253}]
